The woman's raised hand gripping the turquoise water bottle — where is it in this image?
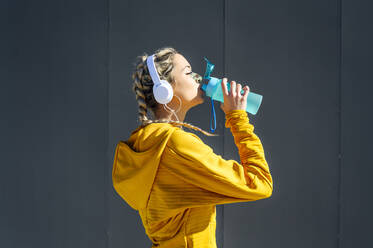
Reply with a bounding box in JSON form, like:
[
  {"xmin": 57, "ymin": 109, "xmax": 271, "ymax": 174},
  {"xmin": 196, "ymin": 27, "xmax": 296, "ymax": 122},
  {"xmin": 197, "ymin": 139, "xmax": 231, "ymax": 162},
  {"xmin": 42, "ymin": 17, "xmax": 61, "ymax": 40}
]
[{"xmin": 220, "ymin": 78, "xmax": 250, "ymax": 114}]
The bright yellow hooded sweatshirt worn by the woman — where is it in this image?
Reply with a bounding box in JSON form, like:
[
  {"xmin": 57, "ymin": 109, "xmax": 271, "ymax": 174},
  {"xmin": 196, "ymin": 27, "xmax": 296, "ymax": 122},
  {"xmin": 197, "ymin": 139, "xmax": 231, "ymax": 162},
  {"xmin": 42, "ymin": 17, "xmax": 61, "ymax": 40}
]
[{"xmin": 112, "ymin": 110, "xmax": 273, "ymax": 248}]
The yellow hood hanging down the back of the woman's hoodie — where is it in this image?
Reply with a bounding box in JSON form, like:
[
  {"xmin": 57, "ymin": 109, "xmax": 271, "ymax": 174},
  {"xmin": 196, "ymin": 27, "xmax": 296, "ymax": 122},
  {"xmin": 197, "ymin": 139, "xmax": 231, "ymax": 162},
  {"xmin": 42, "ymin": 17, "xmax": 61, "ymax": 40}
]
[{"xmin": 112, "ymin": 123, "xmax": 180, "ymax": 210}]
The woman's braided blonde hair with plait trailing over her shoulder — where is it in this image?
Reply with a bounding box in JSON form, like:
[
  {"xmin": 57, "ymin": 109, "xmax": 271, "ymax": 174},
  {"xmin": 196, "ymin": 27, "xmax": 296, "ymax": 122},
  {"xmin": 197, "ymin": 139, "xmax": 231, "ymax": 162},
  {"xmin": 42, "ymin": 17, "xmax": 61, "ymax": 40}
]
[{"xmin": 132, "ymin": 47, "xmax": 219, "ymax": 136}]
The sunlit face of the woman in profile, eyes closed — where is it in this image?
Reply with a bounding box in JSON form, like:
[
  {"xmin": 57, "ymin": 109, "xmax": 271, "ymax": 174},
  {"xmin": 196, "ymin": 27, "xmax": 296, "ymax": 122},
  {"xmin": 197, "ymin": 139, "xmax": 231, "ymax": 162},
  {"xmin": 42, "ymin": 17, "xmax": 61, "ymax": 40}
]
[{"xmin": 171, "ymin": 54, "xmax": 204, "ymax": 107}]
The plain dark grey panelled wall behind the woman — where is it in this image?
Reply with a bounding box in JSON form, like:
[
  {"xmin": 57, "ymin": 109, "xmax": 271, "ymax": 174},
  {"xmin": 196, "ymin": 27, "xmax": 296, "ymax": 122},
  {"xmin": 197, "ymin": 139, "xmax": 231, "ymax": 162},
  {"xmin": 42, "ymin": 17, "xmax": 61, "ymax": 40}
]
[{"xmin": 0, "ymin": 0, "xmax": 373, "ymax": 248}]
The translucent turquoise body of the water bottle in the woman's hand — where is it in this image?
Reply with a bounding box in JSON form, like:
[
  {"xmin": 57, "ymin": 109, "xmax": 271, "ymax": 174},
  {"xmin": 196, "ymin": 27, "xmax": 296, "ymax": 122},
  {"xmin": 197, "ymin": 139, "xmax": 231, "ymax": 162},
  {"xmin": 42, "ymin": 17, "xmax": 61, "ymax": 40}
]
[{"xmin": 201, "ymin": 77, "xmax": 263, "ymax": 115}]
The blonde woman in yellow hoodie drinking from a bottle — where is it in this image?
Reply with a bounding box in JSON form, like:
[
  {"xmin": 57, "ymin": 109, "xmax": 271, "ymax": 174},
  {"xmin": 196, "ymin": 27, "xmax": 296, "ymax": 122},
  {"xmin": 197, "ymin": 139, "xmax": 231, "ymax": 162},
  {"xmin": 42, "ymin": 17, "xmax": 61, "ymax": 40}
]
[{"xmin": 112, "ymin": 47, "xmax": 273, "ymax": 248}]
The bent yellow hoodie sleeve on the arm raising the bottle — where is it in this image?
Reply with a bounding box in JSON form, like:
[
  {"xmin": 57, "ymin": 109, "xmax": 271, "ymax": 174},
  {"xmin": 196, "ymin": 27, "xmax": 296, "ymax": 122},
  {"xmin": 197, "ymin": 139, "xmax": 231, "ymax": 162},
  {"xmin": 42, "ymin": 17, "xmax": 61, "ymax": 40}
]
[{"xmin": 163, "ymin": 110, "xmax": 273, "ymax": 207}]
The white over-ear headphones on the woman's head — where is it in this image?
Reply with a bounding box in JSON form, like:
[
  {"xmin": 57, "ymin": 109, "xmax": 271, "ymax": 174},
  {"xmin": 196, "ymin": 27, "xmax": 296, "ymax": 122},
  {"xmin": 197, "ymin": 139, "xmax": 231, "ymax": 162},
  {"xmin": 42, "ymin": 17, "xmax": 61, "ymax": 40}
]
[{"xmin": 146, "ymin": 54, "xmax": 174, "ymax": 104}]
